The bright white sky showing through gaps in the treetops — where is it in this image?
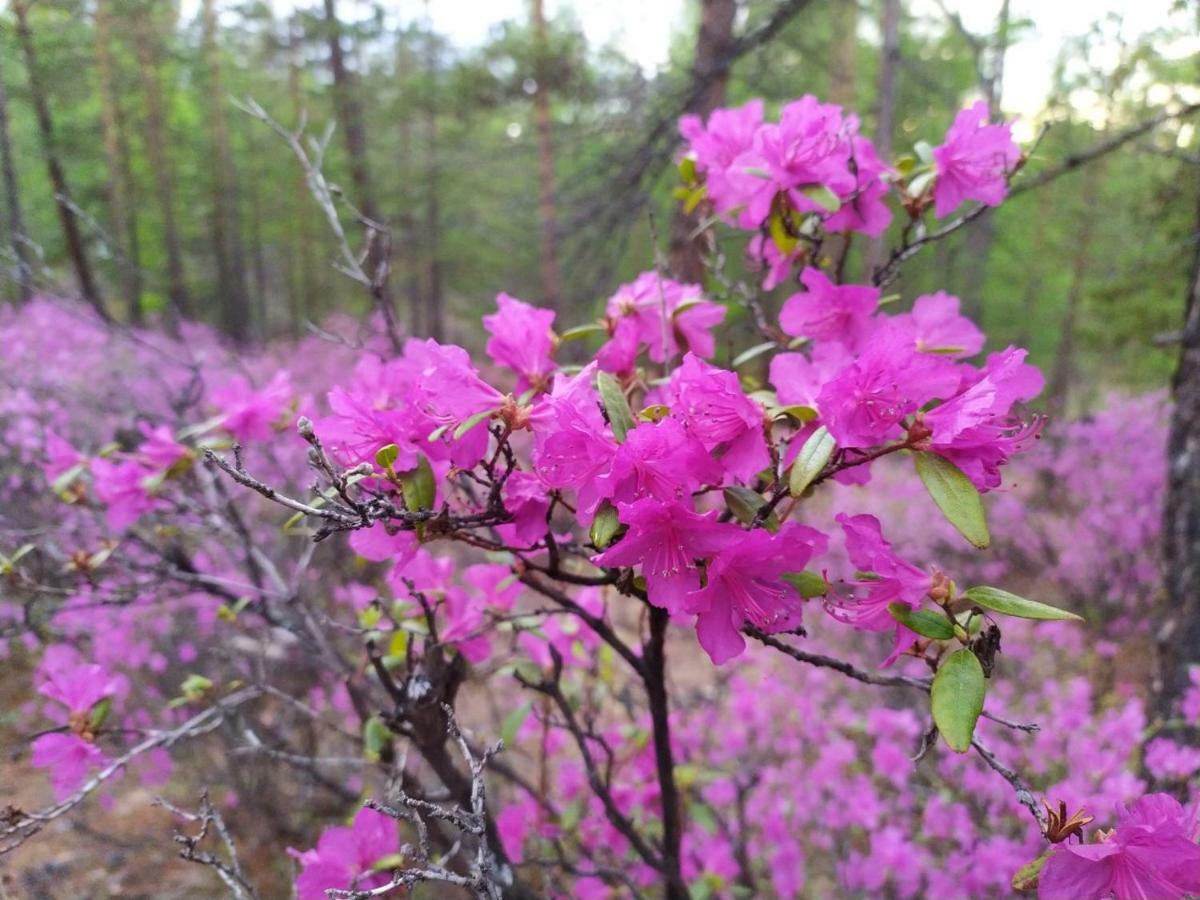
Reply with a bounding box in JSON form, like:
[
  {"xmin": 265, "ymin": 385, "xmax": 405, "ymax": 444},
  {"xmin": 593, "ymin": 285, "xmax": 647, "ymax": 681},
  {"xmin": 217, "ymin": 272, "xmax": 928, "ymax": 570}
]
[{"xmin": 223, "ymin": 0, "xmax": 1200, "ymax": 116}]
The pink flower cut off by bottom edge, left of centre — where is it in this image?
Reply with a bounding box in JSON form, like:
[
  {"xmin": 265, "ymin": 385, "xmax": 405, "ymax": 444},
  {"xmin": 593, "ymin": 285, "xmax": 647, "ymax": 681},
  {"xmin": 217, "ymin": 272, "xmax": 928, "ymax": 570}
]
[{"xmin": 288, "ymin": 808, "xmax": 398, "ymax": 900}]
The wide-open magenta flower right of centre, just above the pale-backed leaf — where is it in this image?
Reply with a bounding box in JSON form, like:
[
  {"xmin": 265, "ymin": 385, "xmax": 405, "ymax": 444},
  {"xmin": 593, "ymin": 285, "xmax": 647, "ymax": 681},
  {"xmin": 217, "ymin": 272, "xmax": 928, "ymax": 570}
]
[{"xmin": 817, "ymin": 331, "xmax": 960, "ymax": 448}]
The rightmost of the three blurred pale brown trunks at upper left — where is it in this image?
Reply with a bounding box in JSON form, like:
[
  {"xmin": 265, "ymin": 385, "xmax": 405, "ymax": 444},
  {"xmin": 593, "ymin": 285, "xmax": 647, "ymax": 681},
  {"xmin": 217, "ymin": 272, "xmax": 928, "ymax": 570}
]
[{"xmin": 200, "ymin": 0, "xmax": 250, "ymax": 343}]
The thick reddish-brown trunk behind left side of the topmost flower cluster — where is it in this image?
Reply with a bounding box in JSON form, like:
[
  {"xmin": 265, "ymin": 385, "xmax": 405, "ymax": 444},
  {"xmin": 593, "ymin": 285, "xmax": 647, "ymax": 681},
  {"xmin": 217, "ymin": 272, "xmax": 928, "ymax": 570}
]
[{"xmin": 670, "ymin": 0, "xmax": 738, "ymax": 284}]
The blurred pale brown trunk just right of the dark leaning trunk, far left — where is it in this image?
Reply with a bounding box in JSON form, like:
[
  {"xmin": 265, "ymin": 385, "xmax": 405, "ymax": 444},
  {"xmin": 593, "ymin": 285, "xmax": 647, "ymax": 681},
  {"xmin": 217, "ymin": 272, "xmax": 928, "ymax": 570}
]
[{"xmin": 95, "ymin": 0, "xmax": 143, "ymax": 325}]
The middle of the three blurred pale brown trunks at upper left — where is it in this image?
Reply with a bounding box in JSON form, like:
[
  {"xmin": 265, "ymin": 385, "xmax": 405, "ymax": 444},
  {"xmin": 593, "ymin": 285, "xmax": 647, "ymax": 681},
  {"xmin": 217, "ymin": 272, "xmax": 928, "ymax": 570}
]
[{"xmin": 133, "ymin": 7, "xmax": 191, "ymax": 335}]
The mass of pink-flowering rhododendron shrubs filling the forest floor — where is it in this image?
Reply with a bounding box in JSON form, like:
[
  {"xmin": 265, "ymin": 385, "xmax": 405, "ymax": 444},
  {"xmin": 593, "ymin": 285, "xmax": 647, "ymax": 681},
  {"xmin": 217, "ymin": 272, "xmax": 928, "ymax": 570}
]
[{"xmin": 0, "ymin": 97, "xmax": 1196, "ymax": 899}]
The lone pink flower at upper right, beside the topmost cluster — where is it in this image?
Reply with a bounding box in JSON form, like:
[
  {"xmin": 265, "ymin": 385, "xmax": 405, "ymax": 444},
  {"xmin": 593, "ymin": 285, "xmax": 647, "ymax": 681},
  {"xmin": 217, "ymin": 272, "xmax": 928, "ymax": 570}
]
[{"xmin": 934, "ymin": 100, "xmax": 1021, "ymax": 217}]
